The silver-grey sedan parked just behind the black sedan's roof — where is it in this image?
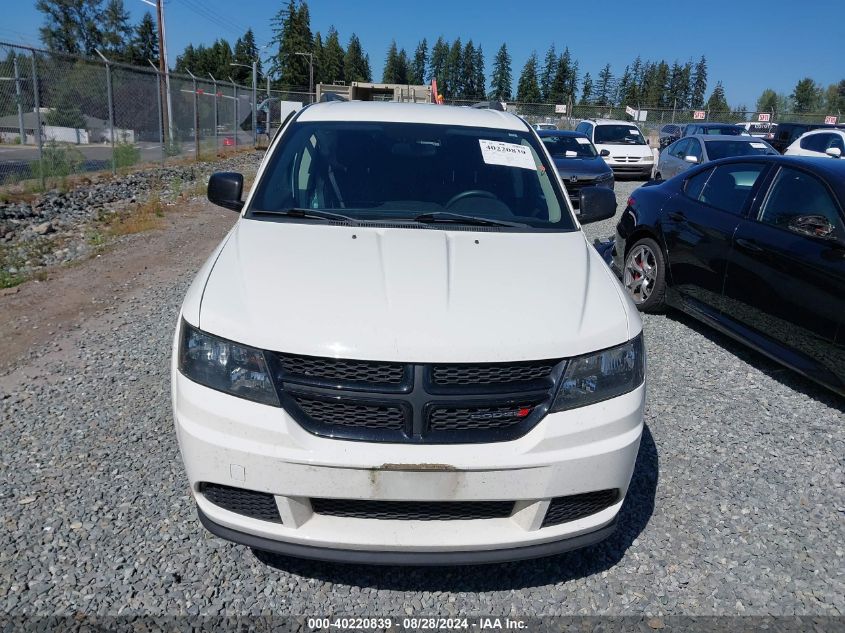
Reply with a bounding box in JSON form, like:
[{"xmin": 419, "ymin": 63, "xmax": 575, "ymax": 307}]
[{"xmin": 654, "ymin": 134, "xmax": 777, "ymax": 180}]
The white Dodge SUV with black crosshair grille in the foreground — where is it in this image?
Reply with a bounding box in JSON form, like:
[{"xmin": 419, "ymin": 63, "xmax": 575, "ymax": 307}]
[{"xmin": 172, "ymin": 102, "xmax": 645, "ymax": 564}]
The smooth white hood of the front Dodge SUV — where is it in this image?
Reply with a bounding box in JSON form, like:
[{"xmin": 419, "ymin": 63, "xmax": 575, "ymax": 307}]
[{"xmin": 196, "ymin": 219, "xmax": 641, "ymax": 362}]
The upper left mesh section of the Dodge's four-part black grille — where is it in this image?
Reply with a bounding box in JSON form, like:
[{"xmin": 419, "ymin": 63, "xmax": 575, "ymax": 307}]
[{"xmin": 277, "ymin": 354, "xmax": 405, "ymax": 385}]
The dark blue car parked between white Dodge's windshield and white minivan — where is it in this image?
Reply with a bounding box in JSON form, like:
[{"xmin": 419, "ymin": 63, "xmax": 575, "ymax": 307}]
[{"xmin": 537, "ymin": 130, "xmax": 615, "ymax": 208}]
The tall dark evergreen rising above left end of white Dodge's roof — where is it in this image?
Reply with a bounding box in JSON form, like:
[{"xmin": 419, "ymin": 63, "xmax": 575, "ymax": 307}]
[{"xmin": 270, "ymin": 0, "xmax": 313, "ymax": 88}]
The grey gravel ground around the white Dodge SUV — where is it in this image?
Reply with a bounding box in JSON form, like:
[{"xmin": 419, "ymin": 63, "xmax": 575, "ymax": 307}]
[{"xmin": 0, "ymin": 177, "xmax": 845, "ymax": 616}]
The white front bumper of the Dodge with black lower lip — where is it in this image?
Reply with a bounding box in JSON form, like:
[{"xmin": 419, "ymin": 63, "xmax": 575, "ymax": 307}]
[{"xmin": 172, "ymin": 368, "xmax": 645, "ymax": 564}]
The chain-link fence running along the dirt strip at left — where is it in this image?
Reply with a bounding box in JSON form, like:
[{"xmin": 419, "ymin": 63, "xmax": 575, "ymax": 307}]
[{"xmin": 0, "ymin": 42, "xmax": 313, "ymax": 191}]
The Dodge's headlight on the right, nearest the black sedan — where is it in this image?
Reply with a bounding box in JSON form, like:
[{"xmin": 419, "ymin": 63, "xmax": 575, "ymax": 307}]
[{"xmin": 550, "ymin": 334, "xmax": 645, "ymax": 413}]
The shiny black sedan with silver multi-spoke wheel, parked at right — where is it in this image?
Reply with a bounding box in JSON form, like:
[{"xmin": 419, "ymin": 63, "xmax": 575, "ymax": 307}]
[{"xmin": 609, "ymin": 155, "xmax": 845, "ymax": 395}]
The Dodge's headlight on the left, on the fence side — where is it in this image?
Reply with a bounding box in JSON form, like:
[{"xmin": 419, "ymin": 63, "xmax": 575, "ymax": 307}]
[{"xmin": 179, "ymin": 321, "xmax": 279, "ymax": 407}]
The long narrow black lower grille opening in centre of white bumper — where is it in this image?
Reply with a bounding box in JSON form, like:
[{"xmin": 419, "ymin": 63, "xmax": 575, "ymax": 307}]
[{"xmin": 311, "ymin": 499, "xmax": 513, "ymax": 521}]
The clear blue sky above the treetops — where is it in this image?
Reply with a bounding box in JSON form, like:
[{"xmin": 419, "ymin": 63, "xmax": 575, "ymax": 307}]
[{"xmin": 0, "ymin": 0, "xmax": 845, "ymax": 108}]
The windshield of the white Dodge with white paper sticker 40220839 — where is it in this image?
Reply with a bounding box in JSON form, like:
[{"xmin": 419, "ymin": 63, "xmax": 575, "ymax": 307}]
[{"xmin": 248, "ymin": 121, "xmax": 575, "ymax": 230}]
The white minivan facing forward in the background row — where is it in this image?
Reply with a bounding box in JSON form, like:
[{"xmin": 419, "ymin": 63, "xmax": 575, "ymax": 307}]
[{"xmin": 575, "ymin": 119, "xmax": 654, "ymax": 179}]
